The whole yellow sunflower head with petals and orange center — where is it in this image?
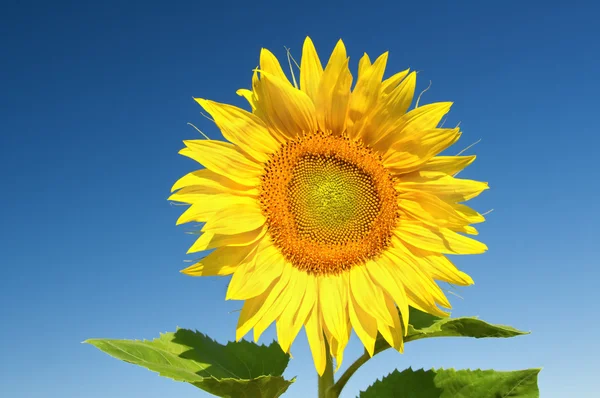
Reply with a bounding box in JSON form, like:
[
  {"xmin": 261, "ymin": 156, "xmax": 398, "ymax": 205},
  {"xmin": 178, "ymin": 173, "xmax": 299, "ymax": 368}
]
[{"xmin": 169, "ymin": 38, "xmax": 488, "ymax": 374}]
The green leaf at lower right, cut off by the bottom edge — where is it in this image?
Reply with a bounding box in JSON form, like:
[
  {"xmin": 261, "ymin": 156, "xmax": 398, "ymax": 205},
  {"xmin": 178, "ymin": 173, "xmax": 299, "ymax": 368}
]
[{"xmin": 360, "ymin": 368, "xmax": 540, "ymax": 398}]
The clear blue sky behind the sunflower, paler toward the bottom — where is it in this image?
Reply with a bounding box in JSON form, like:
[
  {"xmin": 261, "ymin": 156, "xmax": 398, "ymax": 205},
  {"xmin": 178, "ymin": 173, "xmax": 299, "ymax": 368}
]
[{"xmin": 0, "ymin": 0, "xmax": 600, "ymax": 398}]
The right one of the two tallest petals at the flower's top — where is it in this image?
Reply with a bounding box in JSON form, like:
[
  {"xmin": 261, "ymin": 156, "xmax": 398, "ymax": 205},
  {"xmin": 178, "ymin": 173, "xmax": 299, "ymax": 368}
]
[{"xmin": 315, "ymin": 40, "xmax": 352, "ymax": 134}]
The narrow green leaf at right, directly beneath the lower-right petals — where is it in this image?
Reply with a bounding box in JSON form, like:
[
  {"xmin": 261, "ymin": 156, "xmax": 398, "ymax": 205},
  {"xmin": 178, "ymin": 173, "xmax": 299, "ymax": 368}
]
[{"xmin": 375, "ymin": 307, "xmax": 529, "ymax": 352}]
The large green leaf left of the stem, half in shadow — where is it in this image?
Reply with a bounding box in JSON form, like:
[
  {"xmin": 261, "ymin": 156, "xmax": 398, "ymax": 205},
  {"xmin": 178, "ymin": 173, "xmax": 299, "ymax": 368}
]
[{"xmin": 84, "ymin": 329, "xmax": 294, "ymax": 398}]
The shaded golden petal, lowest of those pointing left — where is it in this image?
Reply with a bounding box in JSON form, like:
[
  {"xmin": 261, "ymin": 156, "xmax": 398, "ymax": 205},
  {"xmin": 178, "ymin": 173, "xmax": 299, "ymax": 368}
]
[{"xmin": 181, "ymin": 244, "xmax": 257, "ymax": 276}]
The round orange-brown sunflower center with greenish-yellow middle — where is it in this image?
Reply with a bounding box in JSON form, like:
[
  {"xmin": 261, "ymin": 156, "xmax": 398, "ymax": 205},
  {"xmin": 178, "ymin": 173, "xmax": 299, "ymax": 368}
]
[{"xmin": 260, "ymin": 133, "xmax": 398, "ymax": 274}]
